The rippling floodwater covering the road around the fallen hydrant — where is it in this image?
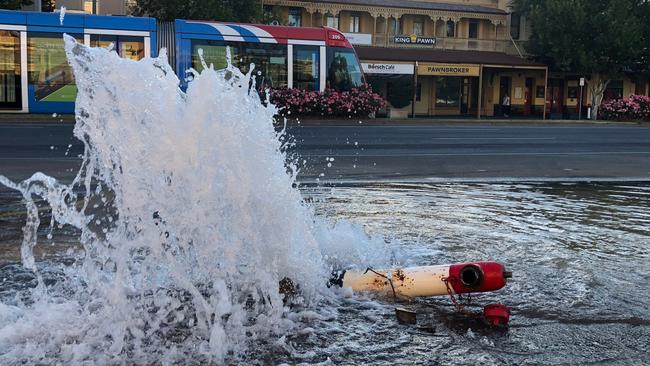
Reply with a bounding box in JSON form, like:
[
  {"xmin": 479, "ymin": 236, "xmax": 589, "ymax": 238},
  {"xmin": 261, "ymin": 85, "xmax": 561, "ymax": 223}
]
[{"xmin": 0, "ymin": 183, "xmax": 650, "ymax": 365}]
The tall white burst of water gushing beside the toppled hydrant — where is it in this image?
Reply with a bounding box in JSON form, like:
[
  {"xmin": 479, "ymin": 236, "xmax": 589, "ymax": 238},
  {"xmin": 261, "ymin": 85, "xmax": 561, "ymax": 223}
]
[{"xmin": 0, "ymin": 37, "xmax": 386, "ymax": 365}]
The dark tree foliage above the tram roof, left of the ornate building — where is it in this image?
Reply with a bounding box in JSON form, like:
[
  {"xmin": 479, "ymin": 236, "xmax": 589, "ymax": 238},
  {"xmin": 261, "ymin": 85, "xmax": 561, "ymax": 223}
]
[{"xmin": 131, "ymin": 0, "xmax": 262, "ymax": 23}]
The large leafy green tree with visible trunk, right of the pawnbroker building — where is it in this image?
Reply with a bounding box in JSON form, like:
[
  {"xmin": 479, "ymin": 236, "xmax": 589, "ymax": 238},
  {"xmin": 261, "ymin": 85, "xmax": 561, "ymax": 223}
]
[{"xmin": 512, "ymin": 0, "xmax": 650, "ymax": 118}]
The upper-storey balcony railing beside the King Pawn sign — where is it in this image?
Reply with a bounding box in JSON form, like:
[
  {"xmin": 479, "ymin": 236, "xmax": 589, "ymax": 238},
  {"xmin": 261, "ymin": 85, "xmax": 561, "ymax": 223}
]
[{"xmin": 364, "ymin": 33, "xmax": 524, "ymax": 56}]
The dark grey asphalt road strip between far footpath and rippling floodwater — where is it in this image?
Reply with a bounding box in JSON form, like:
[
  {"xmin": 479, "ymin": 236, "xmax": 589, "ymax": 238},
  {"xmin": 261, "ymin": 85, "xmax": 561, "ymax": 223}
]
[{"xmin": 0, "ymin": 122, "xmax": 650, "ymax": 182}]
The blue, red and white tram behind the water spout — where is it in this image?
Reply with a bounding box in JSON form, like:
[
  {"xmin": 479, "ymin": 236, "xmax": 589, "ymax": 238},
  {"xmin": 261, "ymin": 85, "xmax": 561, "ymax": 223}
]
[{"xmin": 0, "ymin": 10, "xmax": 365, "ymax": 113}]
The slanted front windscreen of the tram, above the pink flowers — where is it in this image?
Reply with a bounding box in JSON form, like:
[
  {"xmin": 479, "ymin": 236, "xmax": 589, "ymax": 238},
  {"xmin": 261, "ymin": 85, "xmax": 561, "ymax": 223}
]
[{"xmin": 327, "ymin": 47, "xmax": 363, "ymax": 91}]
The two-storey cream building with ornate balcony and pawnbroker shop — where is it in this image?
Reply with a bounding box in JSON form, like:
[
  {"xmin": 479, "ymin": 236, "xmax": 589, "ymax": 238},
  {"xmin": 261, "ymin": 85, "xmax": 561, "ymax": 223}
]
[{"xmin": 263, "ymin": 0, "xmax": 649, "ymax": 118}]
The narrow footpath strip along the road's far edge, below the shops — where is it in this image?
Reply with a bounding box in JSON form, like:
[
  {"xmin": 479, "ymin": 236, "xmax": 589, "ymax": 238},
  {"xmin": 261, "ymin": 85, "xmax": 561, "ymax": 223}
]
[{"xmin": 0, "ymin": 113, "xmax": 650, "ymax": 127}]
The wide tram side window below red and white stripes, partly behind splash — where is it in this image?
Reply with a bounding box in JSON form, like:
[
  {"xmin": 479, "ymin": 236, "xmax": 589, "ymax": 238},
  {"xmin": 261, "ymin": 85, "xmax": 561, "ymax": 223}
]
[{"xmin": 192, "ymin": 40, "xmax": 287, "ymax": 90}]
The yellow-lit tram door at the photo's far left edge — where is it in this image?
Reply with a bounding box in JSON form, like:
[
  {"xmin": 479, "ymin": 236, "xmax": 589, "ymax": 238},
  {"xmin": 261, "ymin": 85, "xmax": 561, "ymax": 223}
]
[{"xmin": 0, "ymin": 30, "xmax": 22, "ymax": 110}]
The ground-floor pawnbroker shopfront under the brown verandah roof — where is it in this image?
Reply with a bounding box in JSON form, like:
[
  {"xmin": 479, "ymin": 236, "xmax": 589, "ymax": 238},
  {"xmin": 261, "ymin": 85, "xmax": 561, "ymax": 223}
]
[{"xmin": 356, "ymin": 47, "xmax": 547, "ymax": 118}]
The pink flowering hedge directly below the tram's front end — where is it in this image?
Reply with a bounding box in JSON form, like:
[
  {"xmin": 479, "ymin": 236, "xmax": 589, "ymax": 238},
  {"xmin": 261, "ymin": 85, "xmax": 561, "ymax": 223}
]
[{"xmin": 271, "ymin": 87, "xmax": 386, "ymax": 118}]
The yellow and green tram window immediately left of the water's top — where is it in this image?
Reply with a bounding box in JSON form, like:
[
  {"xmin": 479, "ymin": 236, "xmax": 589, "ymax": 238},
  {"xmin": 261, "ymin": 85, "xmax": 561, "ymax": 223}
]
[{"xmin": 27, "ymin": 32, "xmax": 83, "ymax": 102}]
